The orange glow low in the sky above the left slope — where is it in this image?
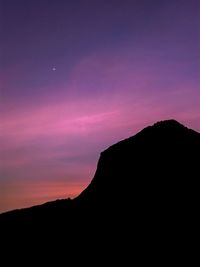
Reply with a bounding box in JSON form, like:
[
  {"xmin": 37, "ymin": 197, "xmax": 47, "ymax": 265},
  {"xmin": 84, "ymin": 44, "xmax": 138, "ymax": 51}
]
[{"xmin": 0, "ymin": 181, "xmax": 87, "ymax": 215}]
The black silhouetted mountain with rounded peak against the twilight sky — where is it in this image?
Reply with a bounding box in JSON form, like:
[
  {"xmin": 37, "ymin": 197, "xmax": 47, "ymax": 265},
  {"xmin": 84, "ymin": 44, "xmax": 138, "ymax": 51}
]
[{"xmin": 0, "ymin": 121, "xmax": 200, "ymax": 266}]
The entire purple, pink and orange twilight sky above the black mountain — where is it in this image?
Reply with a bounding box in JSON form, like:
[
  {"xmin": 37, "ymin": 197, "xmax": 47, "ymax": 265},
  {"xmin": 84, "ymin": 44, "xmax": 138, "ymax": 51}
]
[{"xmin": 0, "ymin": 0, "xmax": 200, "ymax": 212}]
